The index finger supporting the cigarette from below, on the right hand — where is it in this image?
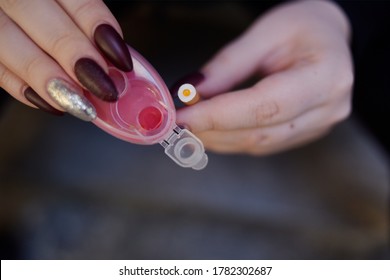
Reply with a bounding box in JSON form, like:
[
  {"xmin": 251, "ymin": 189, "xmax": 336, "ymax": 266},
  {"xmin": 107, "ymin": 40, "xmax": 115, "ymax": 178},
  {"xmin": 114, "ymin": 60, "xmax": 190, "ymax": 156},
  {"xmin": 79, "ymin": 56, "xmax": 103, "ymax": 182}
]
[{"xmin": 177, "ymin": 65, "xmax": 331, "ymax": 132}]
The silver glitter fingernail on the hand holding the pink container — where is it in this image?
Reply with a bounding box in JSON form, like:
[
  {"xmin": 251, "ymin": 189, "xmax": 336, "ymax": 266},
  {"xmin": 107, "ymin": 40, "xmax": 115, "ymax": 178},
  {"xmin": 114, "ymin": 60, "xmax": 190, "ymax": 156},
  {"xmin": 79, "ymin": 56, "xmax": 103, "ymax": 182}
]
[{"xmin": 47, "ymin": 79, "xmax": 96, "ymax": 121}]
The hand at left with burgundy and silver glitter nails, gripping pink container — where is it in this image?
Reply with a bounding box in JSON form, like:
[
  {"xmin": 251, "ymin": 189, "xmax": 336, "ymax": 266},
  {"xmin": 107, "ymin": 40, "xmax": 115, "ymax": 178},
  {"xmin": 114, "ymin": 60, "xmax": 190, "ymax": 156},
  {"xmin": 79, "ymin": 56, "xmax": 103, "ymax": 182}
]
[{"xmin": 0, "ymin": 0, "xmax": 132, "ymax": 121}]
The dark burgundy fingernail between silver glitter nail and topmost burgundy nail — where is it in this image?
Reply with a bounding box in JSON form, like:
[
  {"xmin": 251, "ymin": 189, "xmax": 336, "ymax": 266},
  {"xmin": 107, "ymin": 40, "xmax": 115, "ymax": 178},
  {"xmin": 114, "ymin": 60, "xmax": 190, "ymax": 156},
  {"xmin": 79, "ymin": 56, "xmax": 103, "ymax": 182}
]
[{"xmin": 74, "ymin": 58, "xmax": 118, "ymax": 102}]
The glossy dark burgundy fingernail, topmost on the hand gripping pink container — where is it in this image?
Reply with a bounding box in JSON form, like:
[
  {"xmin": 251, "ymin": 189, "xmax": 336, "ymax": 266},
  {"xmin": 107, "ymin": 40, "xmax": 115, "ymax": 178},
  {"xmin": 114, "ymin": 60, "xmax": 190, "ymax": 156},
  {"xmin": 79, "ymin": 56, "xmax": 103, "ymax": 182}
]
[{"xmin": 94, "ymin": 24, "xmax": 133, "ymax": 72}]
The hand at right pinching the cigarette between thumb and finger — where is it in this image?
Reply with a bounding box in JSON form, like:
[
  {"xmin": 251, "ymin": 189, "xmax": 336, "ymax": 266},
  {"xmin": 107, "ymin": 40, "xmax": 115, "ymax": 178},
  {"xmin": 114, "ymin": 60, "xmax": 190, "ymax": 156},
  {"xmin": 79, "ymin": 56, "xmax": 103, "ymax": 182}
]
[{"xmin": 177, "ymin": 1, "xmax": 353, "ymax": 155}]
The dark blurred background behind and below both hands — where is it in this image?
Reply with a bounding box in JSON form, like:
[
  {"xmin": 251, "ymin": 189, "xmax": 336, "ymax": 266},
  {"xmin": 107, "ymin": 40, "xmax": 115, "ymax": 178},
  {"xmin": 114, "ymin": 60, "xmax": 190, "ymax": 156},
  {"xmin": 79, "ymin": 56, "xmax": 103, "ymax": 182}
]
[{"xmin": 0, "ymin": 1, "xmax": 390, "ymax": 259}]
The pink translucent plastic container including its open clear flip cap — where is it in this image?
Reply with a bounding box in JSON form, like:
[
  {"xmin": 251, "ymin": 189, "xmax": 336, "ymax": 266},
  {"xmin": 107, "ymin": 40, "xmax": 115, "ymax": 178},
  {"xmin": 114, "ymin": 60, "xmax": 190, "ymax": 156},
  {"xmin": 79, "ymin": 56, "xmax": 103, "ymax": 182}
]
[{"xmin": 85, "ymin": 46, "xmax": 208, "ymax": 170}]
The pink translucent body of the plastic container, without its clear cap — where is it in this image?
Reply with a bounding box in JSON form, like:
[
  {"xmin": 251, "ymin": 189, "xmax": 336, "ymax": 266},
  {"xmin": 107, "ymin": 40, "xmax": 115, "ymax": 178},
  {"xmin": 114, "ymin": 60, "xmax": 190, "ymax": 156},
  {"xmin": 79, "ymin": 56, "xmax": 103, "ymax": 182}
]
[{"xmin": 85, "ymin": 44, "xmax": 176, "ymax": 145}]
